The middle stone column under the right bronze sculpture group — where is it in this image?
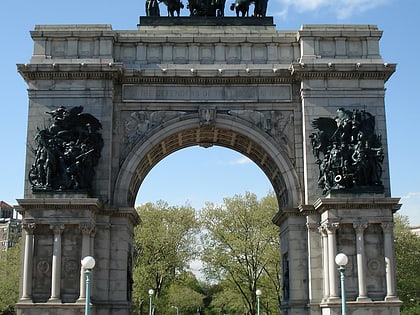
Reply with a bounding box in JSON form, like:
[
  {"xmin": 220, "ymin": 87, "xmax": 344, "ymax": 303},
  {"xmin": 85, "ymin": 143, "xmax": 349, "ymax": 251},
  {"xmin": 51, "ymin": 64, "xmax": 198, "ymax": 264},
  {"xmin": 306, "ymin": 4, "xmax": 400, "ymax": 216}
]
[{"xmin": 353, "ymin": 222, "xmax": 371, "ymax": 302}]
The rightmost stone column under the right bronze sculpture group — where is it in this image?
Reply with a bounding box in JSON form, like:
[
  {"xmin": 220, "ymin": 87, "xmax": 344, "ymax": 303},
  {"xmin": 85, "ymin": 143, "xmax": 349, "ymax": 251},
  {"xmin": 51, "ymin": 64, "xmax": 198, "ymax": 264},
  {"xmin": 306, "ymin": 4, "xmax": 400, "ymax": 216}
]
[{"xmin": 381, "ymin": 222, "xmax": 397, "ymax": 301}]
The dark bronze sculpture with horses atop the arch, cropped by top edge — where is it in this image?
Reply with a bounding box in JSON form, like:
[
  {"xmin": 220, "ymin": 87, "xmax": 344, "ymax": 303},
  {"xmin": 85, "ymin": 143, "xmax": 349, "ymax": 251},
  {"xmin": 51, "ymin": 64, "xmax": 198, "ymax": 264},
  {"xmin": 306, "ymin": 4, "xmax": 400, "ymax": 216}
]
[{"xmin": 146, "ymin": 0, "xmax": 268, "ymax": 17}]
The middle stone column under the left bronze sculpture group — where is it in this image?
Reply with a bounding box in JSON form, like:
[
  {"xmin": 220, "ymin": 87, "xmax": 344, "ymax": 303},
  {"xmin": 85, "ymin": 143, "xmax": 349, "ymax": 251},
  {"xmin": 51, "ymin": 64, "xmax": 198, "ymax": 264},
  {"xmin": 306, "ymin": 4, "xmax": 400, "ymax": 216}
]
[{"xmin": 49, "ymin": 224, "xmax": 64, "ymax": 303}]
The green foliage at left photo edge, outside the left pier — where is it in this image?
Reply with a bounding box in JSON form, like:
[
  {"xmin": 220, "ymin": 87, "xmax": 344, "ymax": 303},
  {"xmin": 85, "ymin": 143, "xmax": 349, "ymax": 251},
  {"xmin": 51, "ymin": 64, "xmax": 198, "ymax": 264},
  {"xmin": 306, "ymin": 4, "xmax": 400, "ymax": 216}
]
[{"xmin": 0, "ymin": 241, "xmax": 20, "ymax": 315}]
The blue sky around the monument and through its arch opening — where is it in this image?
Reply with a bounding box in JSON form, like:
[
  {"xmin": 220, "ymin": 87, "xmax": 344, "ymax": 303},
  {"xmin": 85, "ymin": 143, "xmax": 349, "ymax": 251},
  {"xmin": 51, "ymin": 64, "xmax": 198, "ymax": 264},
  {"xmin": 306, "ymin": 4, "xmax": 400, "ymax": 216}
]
[{"xmin": 0, "ymin": 0, "xmax": 420, "ymax": 225}]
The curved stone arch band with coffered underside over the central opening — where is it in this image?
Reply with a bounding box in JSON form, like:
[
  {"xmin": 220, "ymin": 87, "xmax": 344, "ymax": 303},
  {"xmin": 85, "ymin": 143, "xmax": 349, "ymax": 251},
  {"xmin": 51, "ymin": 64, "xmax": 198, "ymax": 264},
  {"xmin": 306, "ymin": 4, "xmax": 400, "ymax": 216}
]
[{"xmin": 114, "ymin": 115, "xmax": 302, "ymax": 207}]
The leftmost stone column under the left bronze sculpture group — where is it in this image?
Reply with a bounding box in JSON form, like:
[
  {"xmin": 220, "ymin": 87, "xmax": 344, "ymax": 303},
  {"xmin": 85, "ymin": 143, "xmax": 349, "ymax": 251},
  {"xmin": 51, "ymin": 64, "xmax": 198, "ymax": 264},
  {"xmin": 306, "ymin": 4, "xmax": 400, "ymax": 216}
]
[{"xmin": 20, "ymin": 223, "xmax": 36, "ymax": 302}]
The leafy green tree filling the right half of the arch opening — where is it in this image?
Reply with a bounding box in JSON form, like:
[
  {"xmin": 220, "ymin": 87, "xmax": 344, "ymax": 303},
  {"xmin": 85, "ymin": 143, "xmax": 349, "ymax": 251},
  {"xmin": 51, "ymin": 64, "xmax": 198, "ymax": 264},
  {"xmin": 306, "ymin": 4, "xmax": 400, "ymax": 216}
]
[{"xmin": 201, "ymin": 192, "xmax": 281, "ymax": 315}]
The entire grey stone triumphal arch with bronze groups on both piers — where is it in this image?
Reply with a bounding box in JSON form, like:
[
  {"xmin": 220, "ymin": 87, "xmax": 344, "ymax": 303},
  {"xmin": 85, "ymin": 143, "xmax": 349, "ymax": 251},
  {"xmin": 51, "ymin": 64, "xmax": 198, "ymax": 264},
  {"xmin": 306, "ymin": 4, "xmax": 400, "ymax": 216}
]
[{"xmin": 16, "ymin": 16, "xmax": 401, "ymax": 315}]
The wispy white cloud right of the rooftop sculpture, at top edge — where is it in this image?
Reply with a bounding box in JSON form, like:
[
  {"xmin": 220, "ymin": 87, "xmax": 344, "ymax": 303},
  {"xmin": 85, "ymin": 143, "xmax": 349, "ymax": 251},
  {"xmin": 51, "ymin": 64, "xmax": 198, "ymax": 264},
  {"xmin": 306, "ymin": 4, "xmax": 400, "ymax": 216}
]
[{"xmin": 275, "ymin": 0, "xmax": 389, "ymax": 20}]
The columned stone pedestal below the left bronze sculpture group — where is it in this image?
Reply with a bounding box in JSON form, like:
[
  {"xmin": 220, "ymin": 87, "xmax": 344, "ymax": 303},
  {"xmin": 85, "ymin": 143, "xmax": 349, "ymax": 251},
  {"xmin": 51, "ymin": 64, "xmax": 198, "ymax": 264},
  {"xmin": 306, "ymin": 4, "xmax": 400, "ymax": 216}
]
[{"xmin": 16, "ymin": 199, "xmax": 139, "ymax": 315}]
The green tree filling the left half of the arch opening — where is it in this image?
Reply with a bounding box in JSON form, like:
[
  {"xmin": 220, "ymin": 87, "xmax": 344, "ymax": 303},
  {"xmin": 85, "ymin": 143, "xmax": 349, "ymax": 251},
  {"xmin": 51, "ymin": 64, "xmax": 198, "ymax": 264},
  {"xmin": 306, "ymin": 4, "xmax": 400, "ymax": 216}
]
[{"xmin": 133, "ymin": 201, "xmax": 198, "ymax": 313}]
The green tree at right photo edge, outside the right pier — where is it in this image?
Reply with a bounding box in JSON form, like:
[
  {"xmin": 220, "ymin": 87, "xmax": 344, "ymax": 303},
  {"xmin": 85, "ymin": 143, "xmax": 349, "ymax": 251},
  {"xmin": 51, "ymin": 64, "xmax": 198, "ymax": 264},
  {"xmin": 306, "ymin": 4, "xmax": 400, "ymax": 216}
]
[{"xmin": 394, "ymin": 215, "xmax": 420, "ymax": 315}]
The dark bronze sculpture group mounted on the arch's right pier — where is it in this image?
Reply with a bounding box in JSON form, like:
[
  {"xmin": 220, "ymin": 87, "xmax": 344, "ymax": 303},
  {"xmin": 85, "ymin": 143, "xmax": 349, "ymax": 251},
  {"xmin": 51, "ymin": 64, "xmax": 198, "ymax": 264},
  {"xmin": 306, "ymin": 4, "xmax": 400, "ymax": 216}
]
[{"xmin": 310, "ymin": 108, "xmax": 384, "ymax": 194}]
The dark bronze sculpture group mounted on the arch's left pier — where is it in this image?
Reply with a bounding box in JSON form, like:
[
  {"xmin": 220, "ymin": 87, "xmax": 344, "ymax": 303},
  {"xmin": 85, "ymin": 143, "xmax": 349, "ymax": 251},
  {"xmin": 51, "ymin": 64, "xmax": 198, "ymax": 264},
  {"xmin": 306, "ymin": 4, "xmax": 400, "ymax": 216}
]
[{"xmin": 29, "ymin": 106, "xmax": 104, "ymax": 192}]
